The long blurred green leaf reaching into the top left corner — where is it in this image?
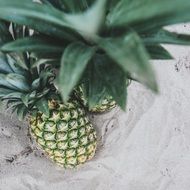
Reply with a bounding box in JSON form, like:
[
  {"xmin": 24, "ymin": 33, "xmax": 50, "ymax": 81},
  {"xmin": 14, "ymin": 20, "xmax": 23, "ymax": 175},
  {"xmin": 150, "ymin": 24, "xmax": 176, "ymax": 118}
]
[{"xmin": 0, "ymin": 0, "xmax": 79, "ymax": 40}]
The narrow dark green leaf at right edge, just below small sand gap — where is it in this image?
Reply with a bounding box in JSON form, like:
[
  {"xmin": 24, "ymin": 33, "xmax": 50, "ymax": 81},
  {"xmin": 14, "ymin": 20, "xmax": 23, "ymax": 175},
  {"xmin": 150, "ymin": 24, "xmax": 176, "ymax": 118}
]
[{"xmin": 141, "ymin": 29, "xmax": 190, "ymax": 45}]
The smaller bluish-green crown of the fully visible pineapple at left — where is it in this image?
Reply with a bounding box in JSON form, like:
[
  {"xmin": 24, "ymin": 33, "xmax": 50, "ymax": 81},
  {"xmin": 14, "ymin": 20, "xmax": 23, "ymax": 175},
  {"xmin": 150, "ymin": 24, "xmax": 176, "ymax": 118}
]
[{"xmin": 0, "ymin": 22, "xmax": 56, "ymax": 120}]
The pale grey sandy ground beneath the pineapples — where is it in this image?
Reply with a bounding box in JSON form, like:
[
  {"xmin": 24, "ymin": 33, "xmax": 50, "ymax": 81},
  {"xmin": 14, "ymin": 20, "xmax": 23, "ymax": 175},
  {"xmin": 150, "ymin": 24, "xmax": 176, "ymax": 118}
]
[{"xmin": 0, "ymin": 25, "xmax": 190, "ymax": 190}]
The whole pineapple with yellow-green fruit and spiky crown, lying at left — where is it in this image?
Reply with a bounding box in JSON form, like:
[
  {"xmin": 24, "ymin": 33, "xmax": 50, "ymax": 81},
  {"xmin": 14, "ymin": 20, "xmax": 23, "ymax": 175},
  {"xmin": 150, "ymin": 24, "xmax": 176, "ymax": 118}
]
[{"xmin": 0, "ymin": 23, "xmax": 97, "ymax": 168}]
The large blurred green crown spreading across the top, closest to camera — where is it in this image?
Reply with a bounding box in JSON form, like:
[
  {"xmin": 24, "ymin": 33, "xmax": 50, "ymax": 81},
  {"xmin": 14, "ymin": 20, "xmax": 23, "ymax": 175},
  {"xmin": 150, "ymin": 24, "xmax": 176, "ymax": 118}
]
[{"xmin": 0, "ymin": 0, "xmax": 190, "ymax": 109}]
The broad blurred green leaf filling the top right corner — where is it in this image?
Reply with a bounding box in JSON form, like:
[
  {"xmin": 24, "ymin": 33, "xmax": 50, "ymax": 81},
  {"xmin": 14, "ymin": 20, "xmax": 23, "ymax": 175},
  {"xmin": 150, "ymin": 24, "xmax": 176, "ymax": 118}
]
[{"xmin": 108, "ymin": 0, "xmax": 190, "ymax": 28}]
